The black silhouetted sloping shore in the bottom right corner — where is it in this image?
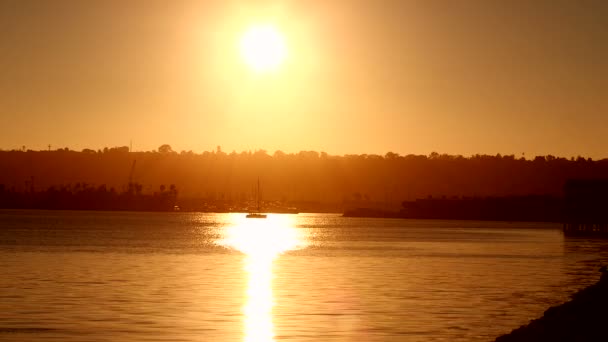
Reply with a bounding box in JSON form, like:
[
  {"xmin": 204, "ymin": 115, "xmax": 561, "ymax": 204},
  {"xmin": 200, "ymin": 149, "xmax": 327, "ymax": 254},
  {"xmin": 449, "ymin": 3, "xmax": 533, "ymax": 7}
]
[{"xmin": 494, "ymin": 266, "xmax": 608, "ymax": 342}]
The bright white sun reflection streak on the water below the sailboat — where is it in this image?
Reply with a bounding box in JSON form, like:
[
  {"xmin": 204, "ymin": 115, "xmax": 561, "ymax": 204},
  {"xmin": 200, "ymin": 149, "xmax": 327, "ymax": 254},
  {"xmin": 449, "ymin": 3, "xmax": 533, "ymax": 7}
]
[{"xmin": 218, "ymin": 215, "xmax": 305, "ymax": 342}]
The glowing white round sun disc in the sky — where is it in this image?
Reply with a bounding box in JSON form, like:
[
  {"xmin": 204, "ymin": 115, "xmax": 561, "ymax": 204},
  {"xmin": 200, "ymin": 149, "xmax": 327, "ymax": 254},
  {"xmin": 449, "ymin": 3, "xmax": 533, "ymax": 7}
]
[{"xmin": 240, "ymin": 24, "xmax": 287, "ymax": 72}]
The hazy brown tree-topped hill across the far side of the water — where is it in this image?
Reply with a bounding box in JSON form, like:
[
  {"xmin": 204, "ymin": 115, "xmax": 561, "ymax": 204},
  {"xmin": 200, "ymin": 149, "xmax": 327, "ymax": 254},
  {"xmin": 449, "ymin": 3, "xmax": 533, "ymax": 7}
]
[{"xmin": 0, "ymin": 145, "xmax": 608, "ymax": 210}]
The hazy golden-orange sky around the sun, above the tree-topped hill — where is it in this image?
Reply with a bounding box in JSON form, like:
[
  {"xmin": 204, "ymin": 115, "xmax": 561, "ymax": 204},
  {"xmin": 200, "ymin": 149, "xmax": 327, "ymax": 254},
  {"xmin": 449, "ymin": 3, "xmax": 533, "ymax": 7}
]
[{"xmin": 0, "ymin": 0, "xmax": 608, "ymax": 158}]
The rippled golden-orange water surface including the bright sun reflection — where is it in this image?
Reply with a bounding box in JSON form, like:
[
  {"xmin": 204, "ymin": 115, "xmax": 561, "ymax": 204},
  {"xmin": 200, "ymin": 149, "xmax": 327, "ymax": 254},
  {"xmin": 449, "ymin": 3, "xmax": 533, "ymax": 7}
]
[{"xmin": 0, "ymin": 211, "xmax": 608, "ymax": 342}]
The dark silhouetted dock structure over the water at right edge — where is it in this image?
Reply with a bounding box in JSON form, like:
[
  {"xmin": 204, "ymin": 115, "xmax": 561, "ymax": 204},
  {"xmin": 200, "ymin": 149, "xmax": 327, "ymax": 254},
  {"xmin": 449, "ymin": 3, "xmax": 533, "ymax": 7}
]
[{"xmin": 564, "ymin": 179, "xmax": 608, "ymax": 237}]
